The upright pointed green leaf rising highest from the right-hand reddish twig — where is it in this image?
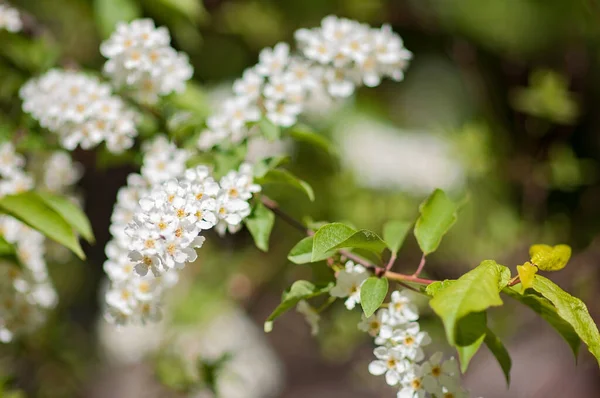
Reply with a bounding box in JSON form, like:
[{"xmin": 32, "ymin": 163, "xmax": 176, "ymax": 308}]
[{"xmin": 415, "ymin": 189, "xmax": 458, "ymax": 255}]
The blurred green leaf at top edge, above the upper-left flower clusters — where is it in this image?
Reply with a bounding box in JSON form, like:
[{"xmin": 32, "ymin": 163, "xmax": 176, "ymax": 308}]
[{"xmin": 94, "ymin": 0, "xmax": 142, "ymax": 38}]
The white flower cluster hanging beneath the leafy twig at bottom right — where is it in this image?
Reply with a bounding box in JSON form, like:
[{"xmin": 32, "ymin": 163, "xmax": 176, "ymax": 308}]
[{"xmin": 330, "ymin": 261, "xmax": 468, "ymax": 398}]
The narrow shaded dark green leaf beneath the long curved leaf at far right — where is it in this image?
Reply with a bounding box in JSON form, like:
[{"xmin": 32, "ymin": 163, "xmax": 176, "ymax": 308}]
[{"xmin": 502, "ymin": 285, "xmax": 581, "ymax": 359}]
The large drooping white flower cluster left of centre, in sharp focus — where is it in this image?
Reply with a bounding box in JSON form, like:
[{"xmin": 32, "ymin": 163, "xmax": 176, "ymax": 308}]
[{"xmin": 104, "ymin": 154, "xmax": 260, "ymax": 324}]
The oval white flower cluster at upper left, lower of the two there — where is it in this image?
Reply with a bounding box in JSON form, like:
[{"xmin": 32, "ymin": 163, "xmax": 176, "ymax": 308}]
[{"xmin": 19, "ymin": 69, "xmax": 137, "ymax": 153}]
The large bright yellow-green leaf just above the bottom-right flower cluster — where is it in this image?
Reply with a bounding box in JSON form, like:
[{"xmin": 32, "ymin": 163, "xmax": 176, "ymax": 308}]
[{"xmin": 429, "ymin": 260, "xmax": 510, "ymax": 345}]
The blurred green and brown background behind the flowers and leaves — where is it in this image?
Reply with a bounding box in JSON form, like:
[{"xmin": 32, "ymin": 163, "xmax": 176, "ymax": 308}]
[{"xmin": 0, "ymin": 0, "xmax": 600, "ymax": 398}]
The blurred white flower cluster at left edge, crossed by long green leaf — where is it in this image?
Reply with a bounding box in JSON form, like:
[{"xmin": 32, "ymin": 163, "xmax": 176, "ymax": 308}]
[{"xmin": 0, "ymin": 143, "xmax": 57, "ymax": 343}]
